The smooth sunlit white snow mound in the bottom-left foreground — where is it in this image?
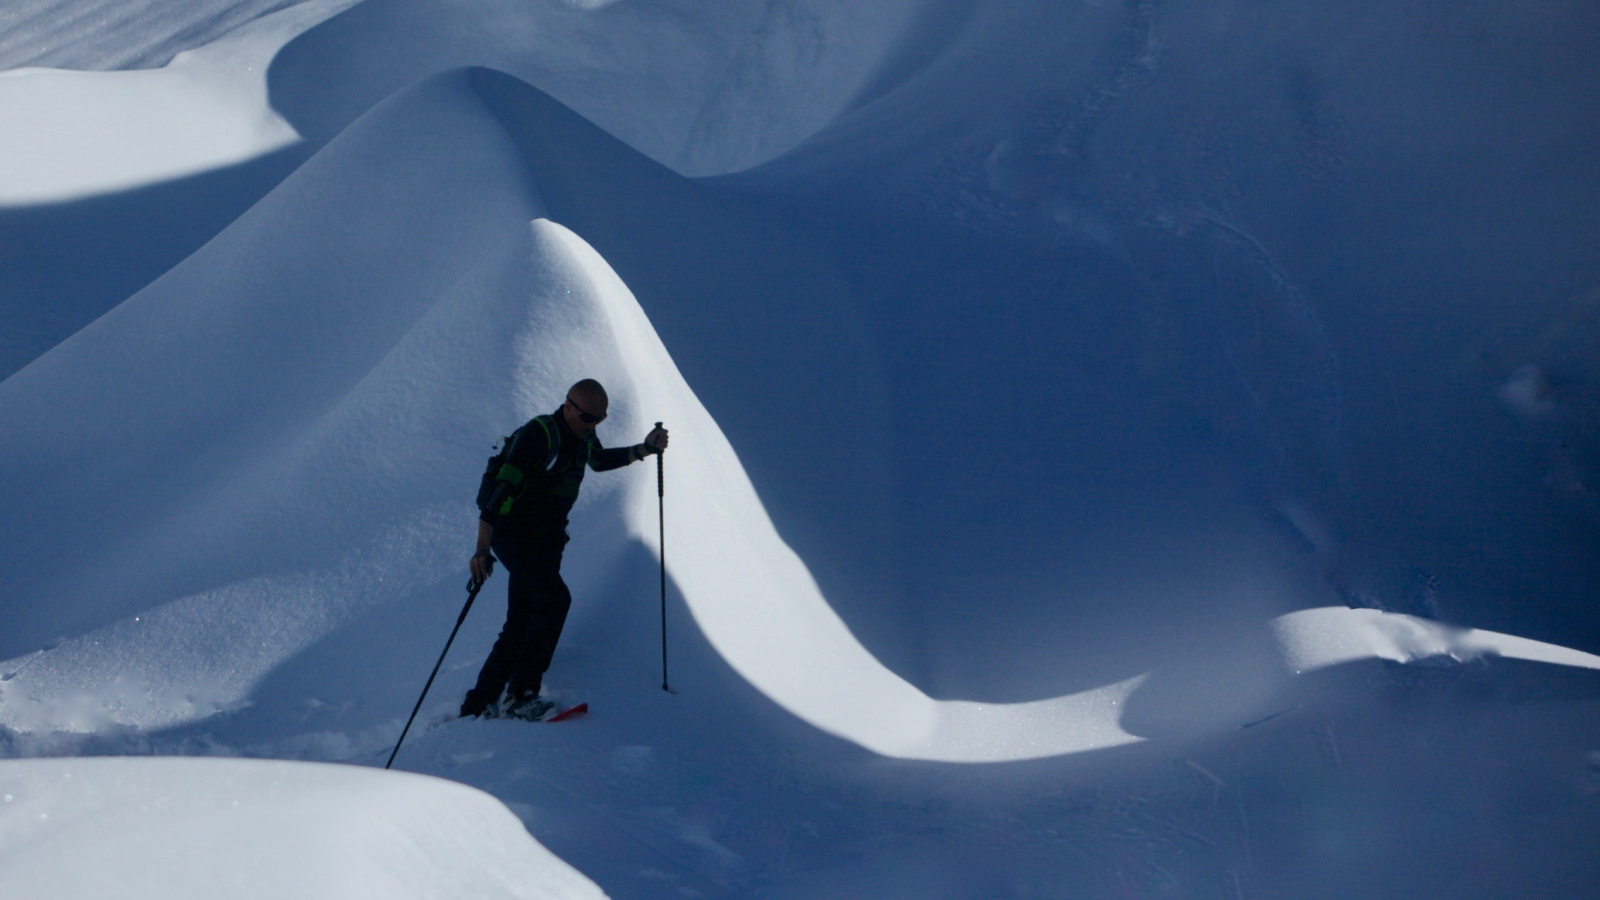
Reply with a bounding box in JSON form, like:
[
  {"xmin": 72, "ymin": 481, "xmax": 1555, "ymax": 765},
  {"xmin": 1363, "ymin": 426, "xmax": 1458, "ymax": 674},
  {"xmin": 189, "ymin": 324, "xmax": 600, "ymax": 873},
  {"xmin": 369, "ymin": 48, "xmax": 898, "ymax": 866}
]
[{"xmin": 0, "ymin": 757, "xmax": 605, "ymax": 900}]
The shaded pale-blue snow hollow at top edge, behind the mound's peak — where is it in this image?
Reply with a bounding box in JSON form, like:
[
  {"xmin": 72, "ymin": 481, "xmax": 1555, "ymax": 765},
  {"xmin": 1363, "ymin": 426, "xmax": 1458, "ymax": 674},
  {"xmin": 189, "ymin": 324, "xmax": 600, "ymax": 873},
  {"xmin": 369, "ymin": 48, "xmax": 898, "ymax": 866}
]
[{"xmin": 270, "ymin": 0, "xmax": 941, "ymax": 175}]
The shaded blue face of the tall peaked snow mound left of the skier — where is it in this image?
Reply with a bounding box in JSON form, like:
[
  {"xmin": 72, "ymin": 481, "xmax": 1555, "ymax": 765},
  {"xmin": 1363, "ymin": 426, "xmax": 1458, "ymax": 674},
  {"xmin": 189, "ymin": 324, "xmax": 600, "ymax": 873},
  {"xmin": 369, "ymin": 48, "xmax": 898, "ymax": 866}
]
[{"xmin": 0, "ymin": 68, "xmax": 550, "ymax": 727}]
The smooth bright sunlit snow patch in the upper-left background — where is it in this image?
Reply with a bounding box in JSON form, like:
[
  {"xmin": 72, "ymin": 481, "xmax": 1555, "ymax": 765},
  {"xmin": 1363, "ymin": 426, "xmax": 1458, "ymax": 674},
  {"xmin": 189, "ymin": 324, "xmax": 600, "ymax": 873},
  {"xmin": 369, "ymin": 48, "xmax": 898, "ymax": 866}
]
[{"xmin": 0, "ymin": 0, "xmax": 360, "ymax": 208}]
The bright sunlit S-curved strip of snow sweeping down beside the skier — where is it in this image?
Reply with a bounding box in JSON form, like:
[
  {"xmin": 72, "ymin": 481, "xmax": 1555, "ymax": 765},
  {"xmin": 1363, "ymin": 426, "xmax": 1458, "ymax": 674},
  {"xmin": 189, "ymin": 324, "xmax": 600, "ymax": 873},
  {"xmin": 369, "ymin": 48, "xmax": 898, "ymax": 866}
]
[{"xmin": 534, "ymin": 223, "xmax": 1141, "ymax": 762}]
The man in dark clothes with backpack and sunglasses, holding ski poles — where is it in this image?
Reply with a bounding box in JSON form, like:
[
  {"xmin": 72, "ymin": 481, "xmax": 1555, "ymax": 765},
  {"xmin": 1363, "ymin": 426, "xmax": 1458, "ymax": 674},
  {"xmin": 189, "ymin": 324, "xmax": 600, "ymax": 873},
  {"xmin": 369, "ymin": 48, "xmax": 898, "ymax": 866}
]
[{"xmin": 461, "ymin": 378, "xmax": 667, "ymax": 719}]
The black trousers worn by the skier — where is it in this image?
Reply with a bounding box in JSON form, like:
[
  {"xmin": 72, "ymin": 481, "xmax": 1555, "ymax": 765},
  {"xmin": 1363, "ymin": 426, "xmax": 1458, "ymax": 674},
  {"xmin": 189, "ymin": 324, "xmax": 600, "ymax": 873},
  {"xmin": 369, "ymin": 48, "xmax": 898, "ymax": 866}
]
[{"xmin": 461, "ymin": 530, "xmax": 573, "ymax": 716}]
